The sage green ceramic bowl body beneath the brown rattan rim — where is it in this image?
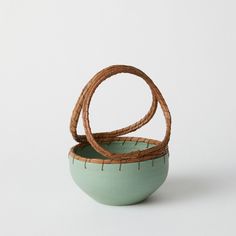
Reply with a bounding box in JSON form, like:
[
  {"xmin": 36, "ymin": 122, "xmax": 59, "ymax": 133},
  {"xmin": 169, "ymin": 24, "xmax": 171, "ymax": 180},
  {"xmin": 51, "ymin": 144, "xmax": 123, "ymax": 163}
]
[{"xmin": 69, "ymin": 141, "xmax": 169, "ymax": 205}]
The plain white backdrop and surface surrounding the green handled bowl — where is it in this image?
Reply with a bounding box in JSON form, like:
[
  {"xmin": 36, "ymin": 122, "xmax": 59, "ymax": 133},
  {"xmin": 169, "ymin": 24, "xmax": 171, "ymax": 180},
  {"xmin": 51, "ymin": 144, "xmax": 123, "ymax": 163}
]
[{"xmin": 0, "ymin": 0, "xmax": 236, "ymax": 236}]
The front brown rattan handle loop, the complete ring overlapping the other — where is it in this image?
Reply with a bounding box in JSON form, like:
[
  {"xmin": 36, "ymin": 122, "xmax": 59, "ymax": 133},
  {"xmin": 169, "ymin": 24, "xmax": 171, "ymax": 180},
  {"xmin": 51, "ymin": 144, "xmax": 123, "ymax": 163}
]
[{"xmin": 82, "ymin": 65, "xmax": 171, "ymax": 159}]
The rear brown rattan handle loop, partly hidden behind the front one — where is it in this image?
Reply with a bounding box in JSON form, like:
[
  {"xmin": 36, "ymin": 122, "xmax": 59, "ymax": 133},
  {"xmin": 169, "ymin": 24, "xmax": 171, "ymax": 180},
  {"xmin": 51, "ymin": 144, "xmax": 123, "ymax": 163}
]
[{"xmin": 70, "ymin": 69, "xmax": 158, "ymax": 142}]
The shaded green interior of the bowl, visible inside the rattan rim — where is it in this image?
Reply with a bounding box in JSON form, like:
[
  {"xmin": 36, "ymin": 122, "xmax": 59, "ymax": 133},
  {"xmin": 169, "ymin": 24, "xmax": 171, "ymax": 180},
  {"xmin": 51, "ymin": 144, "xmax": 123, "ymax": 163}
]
[{"xmin": 74, "ymin": 141, "xmax": 155, "ymax": 160}]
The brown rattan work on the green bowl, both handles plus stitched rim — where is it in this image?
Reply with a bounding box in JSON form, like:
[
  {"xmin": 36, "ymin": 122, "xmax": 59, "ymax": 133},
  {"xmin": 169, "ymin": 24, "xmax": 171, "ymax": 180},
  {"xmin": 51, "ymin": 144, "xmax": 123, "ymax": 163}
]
[{"xmin": 70, "ymin": 65, "xmax": 171, "ymax": 164}]
